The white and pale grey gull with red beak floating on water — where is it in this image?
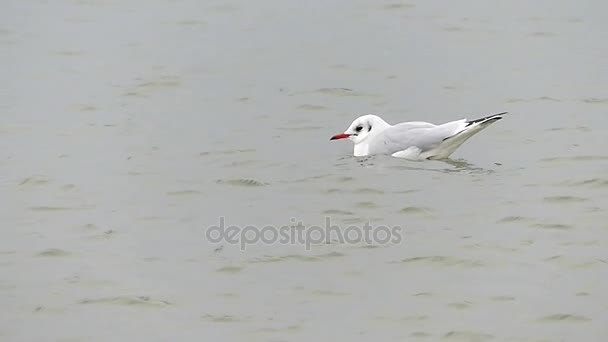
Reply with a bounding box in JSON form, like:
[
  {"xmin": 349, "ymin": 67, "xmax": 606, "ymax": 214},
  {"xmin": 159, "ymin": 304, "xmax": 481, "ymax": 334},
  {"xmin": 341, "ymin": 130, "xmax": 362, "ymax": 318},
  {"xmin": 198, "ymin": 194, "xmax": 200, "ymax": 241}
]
[{"xmin": 330, "ymin": 112, "xmax": 507, "ymax": 160}]
